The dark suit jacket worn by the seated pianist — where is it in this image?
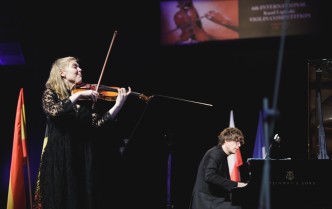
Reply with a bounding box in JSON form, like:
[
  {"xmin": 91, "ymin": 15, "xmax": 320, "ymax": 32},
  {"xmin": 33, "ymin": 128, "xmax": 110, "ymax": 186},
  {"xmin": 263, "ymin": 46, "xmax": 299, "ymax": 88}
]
[{"xmin": 189, "ymin": 146, "xmax": 238, "ymax": 209}]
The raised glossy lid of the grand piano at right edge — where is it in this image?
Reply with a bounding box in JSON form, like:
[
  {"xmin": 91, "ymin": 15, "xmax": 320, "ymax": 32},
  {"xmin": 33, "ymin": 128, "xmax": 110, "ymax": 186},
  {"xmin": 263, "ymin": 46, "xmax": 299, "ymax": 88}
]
[{"xmin": 308, "ymin": 59, "xmax": 332, "ymax": 159}]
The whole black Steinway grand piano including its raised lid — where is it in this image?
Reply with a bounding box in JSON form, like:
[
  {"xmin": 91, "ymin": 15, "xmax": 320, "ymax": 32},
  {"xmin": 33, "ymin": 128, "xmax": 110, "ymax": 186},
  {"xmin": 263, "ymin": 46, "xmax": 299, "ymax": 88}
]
[{"xmin": 231, "ymin": 59, "xmax": 332, "ymax": 209}]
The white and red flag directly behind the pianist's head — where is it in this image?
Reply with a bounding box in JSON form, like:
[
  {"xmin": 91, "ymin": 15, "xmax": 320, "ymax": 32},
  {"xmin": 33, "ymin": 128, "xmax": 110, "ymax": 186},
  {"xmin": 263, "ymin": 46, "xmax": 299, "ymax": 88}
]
[{"xmin": 227, "ymin": 110, "xmax": 243, "ymax": 181}]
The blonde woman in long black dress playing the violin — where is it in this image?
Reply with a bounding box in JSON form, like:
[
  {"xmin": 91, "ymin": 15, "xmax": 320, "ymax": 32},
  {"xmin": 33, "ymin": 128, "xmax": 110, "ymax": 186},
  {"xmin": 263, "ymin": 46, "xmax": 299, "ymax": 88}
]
[{"xmin": 33, "ymin": 57, "xmax": 131, "ymax": 209}]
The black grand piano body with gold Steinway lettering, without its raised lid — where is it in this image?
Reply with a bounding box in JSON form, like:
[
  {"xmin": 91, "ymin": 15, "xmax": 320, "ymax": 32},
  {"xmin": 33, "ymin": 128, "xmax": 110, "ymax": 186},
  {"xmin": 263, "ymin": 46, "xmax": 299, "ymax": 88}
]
[{"xmin": 231, "ymin": 159, "xmax": 332, "ymax": 209}]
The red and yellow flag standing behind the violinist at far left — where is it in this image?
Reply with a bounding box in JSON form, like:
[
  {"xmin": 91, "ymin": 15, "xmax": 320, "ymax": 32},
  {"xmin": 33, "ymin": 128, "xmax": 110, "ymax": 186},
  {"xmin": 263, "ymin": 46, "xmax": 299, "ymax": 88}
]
[{"xmin": 7, "ymin": 88, "xmax": 28, "ymax": 209}]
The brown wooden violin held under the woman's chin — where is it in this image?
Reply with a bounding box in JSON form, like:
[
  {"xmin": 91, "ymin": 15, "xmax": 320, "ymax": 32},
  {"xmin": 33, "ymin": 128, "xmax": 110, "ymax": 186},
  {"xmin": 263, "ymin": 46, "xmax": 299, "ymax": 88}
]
[{"xmin": 72, "ymin": 83, "xmax": 150, "ymax": 102}]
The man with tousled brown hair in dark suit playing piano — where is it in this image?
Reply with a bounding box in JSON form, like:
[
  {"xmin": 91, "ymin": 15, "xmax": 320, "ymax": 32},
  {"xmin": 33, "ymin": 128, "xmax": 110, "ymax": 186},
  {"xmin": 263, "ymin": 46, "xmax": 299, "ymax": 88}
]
[{"xmin": 189, "ymin": 127, "xmax": 247, "ymax": 209}]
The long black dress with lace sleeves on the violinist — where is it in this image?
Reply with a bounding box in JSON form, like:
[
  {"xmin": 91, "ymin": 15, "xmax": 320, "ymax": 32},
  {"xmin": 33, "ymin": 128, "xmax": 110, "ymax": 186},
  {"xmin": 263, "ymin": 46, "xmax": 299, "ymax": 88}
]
[{"xmin": 33, "ymin": 89, "xmax": 111, "ymax": 209}]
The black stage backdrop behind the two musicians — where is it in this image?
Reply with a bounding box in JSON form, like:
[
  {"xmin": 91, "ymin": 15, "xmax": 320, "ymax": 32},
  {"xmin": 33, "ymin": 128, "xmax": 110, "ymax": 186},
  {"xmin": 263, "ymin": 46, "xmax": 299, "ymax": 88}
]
[{"xmin": 0, "ymin": 1, "xmax": 332, "ymax": 209}]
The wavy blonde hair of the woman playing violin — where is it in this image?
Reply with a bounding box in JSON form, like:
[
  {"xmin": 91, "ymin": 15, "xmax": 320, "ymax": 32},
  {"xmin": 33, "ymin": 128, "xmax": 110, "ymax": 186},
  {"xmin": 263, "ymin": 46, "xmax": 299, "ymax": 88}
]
[{"xmin": 45, "ymin": 56, "xmax": 78, "ymax": 99}]
